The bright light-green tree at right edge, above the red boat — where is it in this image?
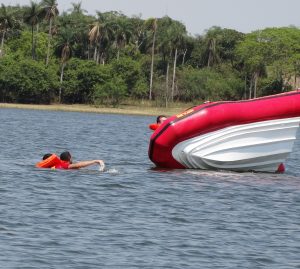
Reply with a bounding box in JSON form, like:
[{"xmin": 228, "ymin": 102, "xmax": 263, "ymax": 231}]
[{"xmin": 235, "ymin": 27, "xmax": 300, "ymax": 95}]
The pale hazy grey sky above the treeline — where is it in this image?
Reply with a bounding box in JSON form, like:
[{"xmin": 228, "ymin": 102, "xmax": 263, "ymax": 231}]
[{"xmin": 1, "ymin": 0, "xmax": 300, "ymax": 35}]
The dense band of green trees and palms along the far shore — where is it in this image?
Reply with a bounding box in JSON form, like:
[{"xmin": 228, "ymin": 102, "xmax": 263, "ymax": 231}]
[{"xmin": 0, "ymin": 0, "xmax": 300, "ymax": 106}]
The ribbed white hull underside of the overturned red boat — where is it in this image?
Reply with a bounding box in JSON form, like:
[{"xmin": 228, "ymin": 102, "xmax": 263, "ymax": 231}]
[{"xmin": 172, "ymin": 117, "xmax": 300, "ymax": 172}]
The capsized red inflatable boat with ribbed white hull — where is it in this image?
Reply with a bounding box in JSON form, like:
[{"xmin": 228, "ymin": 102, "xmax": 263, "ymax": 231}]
[{"xmin": 148, "ymin": 90, "xmax": 300, "ymax": 172}]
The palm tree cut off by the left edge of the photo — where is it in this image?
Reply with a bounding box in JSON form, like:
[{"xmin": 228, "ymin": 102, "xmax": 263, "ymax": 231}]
[{"xmin": 0, "ymin": 4, "xmax": 16, "ymax": 57}]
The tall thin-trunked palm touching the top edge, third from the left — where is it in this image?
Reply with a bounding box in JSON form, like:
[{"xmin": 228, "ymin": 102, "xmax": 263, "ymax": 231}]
[{"xmin": 42, "ymin": 0, "xmax": 59, "ymax": 66}]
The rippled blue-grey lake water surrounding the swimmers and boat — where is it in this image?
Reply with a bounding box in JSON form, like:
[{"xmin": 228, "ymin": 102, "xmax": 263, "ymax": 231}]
[{"xmin": 0, "ymin": 109, "xmax": 300, "ymax": 269}]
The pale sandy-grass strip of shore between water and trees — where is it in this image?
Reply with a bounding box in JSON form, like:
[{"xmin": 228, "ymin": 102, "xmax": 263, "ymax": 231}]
[{"xmin": 0, "ymin": 103, "xmax": 188, "ymax": 116}]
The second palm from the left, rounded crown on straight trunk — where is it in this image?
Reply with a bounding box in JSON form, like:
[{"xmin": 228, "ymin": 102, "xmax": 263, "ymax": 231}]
[{"xmin": 24, "ymin": 1, "xmax": 43, "ymax": 59}]
